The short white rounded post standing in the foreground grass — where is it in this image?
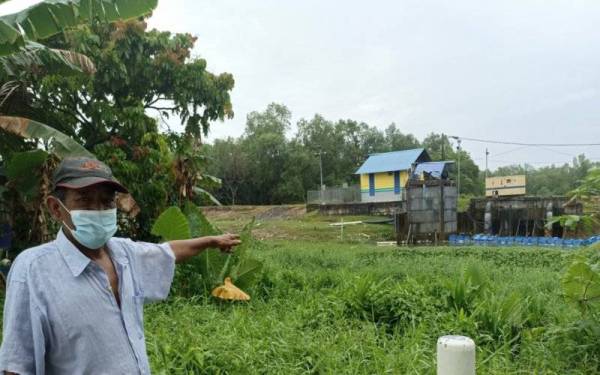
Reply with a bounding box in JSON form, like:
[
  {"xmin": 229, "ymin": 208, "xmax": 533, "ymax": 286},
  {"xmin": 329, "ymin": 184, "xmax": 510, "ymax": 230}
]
[{"xmin": 437, "ymin": 336, "xmax": 475, "ymax": 375}]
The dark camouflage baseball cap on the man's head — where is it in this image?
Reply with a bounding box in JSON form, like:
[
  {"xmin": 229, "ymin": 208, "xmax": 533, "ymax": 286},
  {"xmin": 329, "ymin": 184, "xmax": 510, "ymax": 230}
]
[{"xmin": 52, "ymin": 157, "xmax": 129, "ymax": 193}]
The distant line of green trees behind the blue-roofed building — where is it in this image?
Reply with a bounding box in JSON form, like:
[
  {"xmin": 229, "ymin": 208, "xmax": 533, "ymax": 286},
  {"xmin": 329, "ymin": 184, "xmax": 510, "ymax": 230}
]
[{"xmin": 204, "ymin": 103, "xmax": 598, "ymax": 204}]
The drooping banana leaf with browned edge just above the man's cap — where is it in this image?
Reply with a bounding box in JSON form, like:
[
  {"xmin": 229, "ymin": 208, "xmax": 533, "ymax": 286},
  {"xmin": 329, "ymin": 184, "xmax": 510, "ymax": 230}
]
[{"xmin": 0, "ymin": 116, "xmax": 94, "ymax": 158}]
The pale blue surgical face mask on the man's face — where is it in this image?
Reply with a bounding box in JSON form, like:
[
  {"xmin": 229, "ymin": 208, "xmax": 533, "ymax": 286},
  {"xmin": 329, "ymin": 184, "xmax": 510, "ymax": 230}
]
[{"xmin": 59, "ymin": 200, "xmax": 117, "ymax": 250}]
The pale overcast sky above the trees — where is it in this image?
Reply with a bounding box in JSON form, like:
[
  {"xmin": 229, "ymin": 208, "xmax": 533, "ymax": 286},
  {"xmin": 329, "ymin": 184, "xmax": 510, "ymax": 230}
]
[{"xmin": 0, "ymin": 0, "xmax": 600, "ymax": 169}]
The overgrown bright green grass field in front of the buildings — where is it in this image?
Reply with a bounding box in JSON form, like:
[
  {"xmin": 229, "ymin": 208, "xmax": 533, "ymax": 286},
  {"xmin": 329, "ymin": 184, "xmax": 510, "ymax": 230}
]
[{"xmin": 145, "ymin": 210, "xmax": 600, "ymax": 374}]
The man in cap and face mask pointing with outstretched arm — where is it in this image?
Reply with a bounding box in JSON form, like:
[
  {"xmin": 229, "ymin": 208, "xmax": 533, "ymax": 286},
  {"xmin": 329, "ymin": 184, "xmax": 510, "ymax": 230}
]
[{"xmin": 0, "ymin": 158, "xmax": 240, "ymax": 375}]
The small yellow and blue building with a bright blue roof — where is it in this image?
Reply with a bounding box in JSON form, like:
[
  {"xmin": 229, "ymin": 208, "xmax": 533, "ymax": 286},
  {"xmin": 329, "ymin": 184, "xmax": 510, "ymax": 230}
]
[{"xmin": 356, "ymin": 148, "xmax": 431, "ymax": 202}]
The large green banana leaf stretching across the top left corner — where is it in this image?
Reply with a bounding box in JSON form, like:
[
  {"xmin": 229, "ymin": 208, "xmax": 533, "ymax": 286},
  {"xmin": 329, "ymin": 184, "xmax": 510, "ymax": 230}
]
[{"xmin": 0, "ymin": 0, "xmax": 158, "ymax": 56}]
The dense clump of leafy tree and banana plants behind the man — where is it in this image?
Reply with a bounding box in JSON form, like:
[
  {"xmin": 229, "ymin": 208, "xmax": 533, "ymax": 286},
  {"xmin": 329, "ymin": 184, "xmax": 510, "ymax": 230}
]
[{"xmin": 0, "ymin": 5, "xmax": 234, "ymax": 250}]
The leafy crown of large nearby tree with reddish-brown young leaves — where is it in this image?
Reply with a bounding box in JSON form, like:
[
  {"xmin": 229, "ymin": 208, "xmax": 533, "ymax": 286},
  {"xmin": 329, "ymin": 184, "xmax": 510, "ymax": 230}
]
[{"xmin": 11, "ymin": 20, "xmax": 234, "ymax": 149}]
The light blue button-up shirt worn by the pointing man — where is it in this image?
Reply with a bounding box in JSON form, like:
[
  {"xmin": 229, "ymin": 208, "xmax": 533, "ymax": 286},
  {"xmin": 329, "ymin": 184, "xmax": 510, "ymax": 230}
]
[{"xmin": 0, "ymin": 231, "xmax": 175, "ymax": 375}]
